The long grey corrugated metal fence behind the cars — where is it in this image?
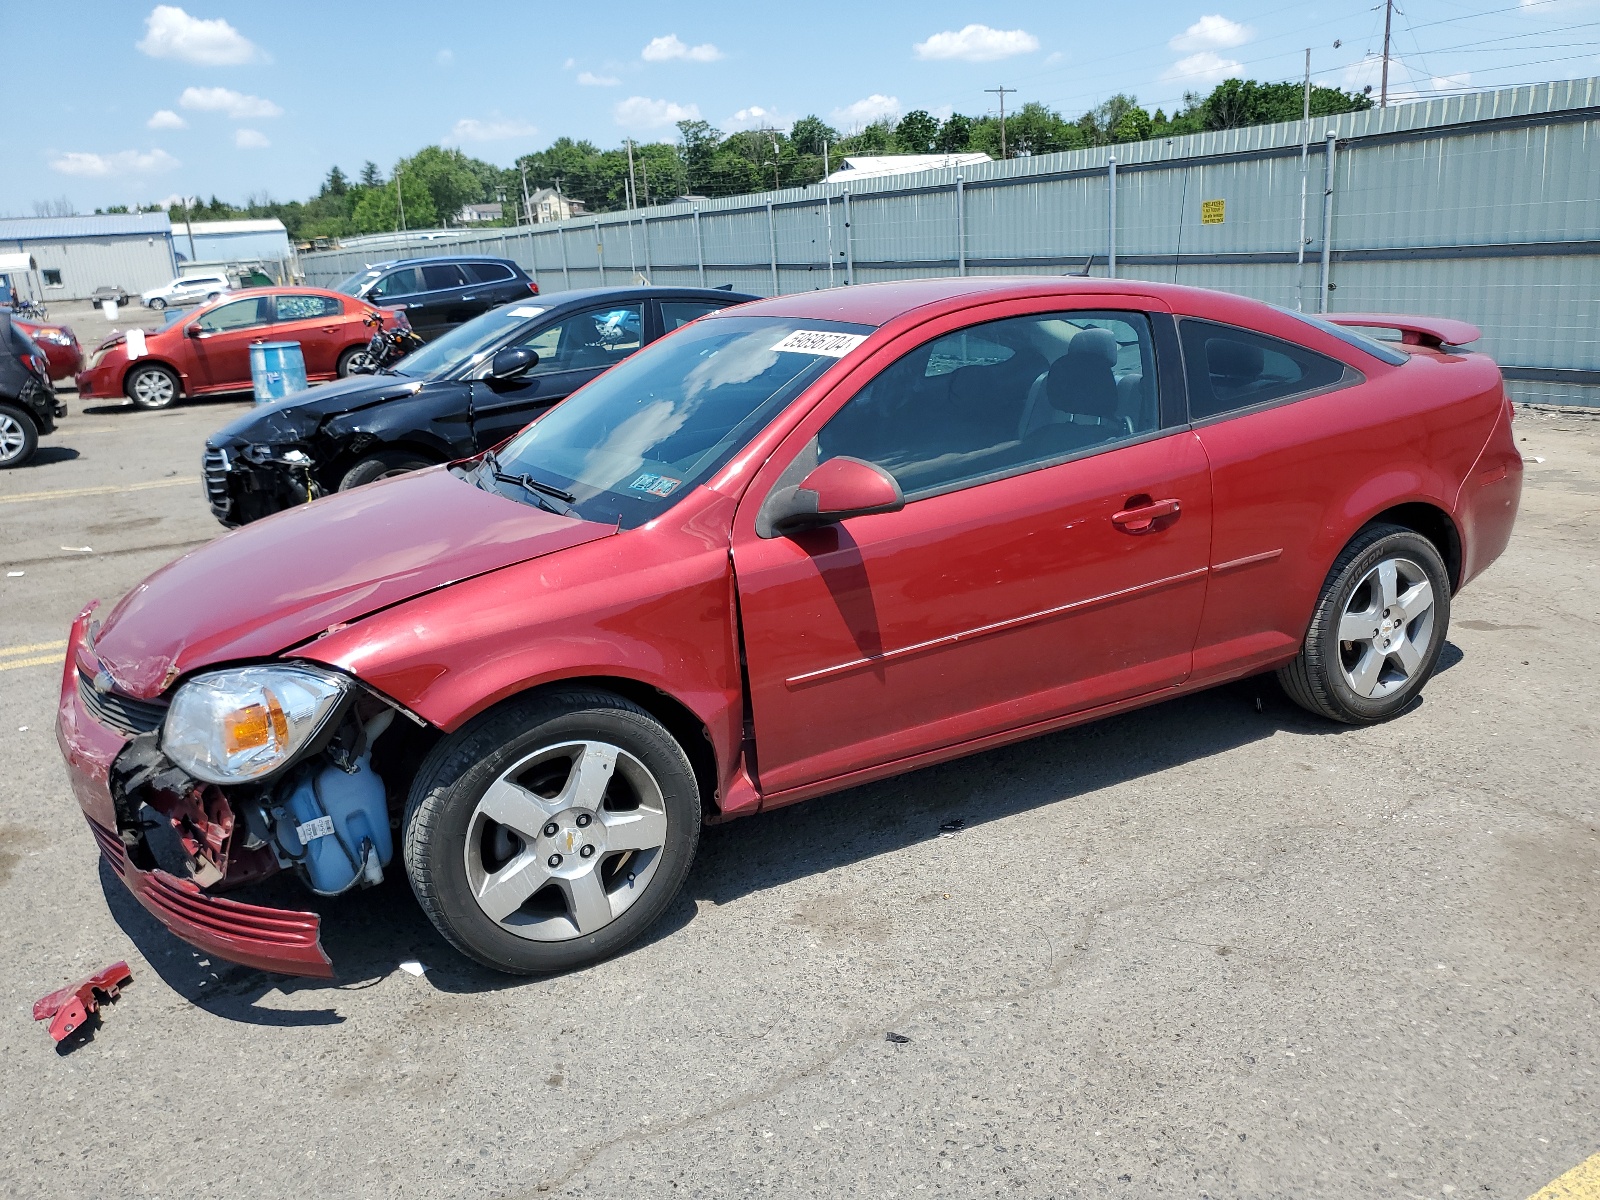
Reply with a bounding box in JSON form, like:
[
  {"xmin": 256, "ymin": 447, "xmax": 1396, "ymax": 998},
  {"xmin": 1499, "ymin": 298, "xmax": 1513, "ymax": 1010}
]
[{"xmin": 301, "ymin": 78, "xmax": 1600, "ymax": 406}]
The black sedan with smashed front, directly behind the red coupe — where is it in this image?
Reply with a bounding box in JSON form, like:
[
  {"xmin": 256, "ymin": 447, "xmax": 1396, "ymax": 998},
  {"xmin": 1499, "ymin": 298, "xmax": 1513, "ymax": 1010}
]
[{"xmin": 203, "ymin": 286, "xmax": 755, "ymax": 525}]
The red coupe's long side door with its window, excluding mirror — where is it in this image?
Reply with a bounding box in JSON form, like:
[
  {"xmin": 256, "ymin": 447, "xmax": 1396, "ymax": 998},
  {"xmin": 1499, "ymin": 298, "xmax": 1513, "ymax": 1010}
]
[{"xmin": 733, "ymin": 296, "xmax": 1211, "ymax": 794}]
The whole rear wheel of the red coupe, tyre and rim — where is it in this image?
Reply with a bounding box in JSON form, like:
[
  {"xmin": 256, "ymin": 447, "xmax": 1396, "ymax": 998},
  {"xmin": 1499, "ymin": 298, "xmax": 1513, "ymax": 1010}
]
[{"xmin": 1278, "ymin": 525, "xmax": 1450, "ymax": 725}]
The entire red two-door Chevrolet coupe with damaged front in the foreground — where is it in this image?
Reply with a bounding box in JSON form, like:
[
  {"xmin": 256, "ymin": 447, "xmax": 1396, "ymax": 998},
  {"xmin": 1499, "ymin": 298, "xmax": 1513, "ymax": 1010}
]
[{"xmin": 59, "ymin": 278, "xmax": 1522, "ymax": 974}]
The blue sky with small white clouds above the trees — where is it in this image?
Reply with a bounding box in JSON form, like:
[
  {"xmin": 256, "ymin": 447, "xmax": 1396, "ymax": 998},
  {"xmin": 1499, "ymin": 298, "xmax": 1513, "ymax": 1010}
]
[{"xmin": 0, "ymin": 0, "xmax": 1600, "ymax": 216}]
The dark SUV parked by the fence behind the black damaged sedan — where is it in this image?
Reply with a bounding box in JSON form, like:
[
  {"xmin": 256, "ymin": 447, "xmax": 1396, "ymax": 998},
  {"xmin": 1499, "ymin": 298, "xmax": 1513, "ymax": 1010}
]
[{"xmin": 333, "ymin": 258, "xmax": 539, "ymax": 341}]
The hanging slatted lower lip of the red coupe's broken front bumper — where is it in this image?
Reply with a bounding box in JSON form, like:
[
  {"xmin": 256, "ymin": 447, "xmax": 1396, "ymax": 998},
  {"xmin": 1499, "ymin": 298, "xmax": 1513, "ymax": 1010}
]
[{"xmin": 90, "ymin": 821, "xmax": 333, "ymax": 979}]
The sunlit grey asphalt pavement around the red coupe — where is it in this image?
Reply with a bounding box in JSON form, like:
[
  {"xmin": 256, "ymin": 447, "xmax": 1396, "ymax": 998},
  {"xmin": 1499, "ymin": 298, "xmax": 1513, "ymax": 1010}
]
[{"xmin": 0, "ymin": 390, "xmax": 1600, "ymax": 1200}]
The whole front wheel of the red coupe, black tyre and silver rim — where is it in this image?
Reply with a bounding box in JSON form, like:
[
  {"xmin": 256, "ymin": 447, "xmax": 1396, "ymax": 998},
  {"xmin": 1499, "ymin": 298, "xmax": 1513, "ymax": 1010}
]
[{"xmin": 405, "ymin": 691, "xmax": 701, "ymax": 974}]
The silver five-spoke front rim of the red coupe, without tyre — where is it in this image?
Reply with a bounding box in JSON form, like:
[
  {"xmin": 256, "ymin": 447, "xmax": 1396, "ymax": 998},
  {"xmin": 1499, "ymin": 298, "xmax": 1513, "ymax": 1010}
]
[{"xmin": 464, "ymin": 741, "xmax": 667, "ymax": 942}]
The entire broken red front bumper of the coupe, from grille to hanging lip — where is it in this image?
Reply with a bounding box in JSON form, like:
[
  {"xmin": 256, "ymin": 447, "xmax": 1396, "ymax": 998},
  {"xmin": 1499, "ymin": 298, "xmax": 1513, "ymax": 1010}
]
[{"xmin": 56, "ymin": 605, "xmax": 333, "ymax": 978}]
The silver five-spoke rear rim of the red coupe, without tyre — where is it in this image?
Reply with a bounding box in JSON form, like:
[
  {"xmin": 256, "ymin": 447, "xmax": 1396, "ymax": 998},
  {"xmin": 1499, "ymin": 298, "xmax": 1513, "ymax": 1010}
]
[{"xmin": 1339, "ymin": 558, "xmax": 1434, "ymax": 699}]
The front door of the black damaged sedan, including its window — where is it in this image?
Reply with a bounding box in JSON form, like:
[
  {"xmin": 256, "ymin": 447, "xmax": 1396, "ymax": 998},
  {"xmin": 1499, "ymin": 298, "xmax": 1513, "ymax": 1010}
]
[{"xmin": 472, "ymin": 301, "xmax": 645, "ymax": 450}]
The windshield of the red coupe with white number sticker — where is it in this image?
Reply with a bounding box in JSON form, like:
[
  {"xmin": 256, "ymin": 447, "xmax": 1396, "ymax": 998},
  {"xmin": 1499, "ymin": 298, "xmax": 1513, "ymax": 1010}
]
[{"xmin": 474, "ymin": 317, "xmax": 872, "ymax": 528}]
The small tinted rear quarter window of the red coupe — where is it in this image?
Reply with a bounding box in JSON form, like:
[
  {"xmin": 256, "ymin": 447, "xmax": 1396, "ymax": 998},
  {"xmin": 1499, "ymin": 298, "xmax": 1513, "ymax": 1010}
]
[{"xmin": 1178, "ymin": 318, "xmax": 1346, "ymax": 421}]
